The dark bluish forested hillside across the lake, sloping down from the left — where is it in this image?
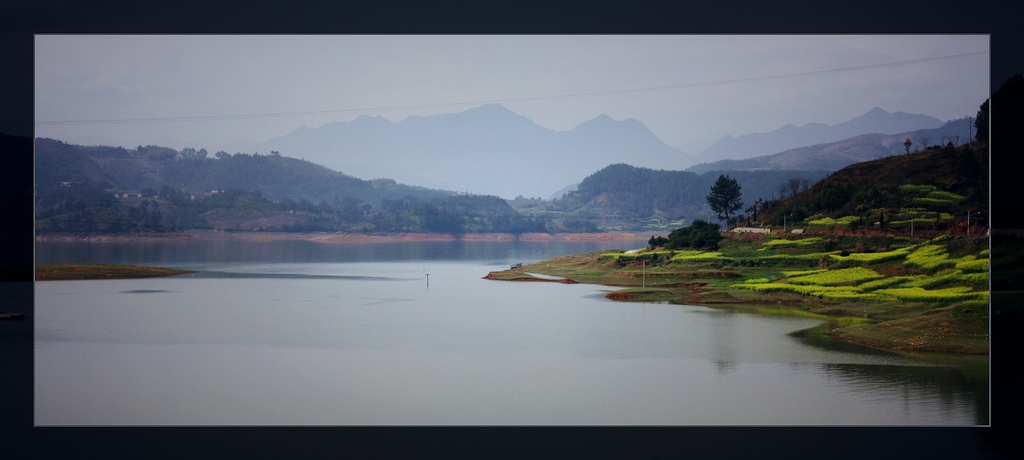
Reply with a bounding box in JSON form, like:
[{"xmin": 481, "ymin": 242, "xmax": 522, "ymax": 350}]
[{"xmin": 36, "ymin": 138, "xmax": 547, "ymax": 235}]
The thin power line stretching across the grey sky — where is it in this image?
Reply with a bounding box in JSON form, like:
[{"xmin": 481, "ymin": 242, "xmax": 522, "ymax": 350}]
[{"xmin": 36, "ymin": 51, "xmax": 988, "ymax": 126}]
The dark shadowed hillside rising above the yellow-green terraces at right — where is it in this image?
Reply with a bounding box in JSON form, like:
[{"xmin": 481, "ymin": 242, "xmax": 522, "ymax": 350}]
[{"xmin": 752, "ymin": 142, "xmax": 988, "ymax": 236}]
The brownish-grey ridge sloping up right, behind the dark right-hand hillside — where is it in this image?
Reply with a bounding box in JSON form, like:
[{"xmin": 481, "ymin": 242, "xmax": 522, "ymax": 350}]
[{"xmin": 686, "ymin": 118, "xmax": 972, "ymax": 174}]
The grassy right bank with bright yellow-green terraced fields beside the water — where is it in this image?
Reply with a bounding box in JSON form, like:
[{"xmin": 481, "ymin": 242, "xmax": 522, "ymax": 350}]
[{"xmin": 489, "ymin": 234, "xmax": 988, "ymax": 354}]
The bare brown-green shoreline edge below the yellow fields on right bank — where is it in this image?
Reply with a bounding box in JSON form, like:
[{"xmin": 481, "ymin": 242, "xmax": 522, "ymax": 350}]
[{"xmin": 484, "ymin": 251, "xmax": 989, "ymax": 357}]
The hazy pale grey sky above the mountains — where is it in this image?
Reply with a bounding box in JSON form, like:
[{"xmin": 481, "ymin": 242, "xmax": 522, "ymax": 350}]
[{"xmin": 35, "ymin": 35, "xmax": 989, "ymax": 151}]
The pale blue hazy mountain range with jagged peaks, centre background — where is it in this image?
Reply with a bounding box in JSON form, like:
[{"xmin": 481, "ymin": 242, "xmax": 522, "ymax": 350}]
[{"xmin": 247, "ymin": 104, "xmax": 692, "ymax": 199}]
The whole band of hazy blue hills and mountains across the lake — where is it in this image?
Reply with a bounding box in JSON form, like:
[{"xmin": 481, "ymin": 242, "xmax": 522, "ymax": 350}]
[{"xmin": 37, "ymin": 104, "xmax": 968, "ymax": 235}]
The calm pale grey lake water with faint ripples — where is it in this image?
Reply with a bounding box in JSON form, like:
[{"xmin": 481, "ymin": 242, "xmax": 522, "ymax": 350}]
[{"xmin": 35, "ymin": 241, "xmax": 989, "ymax": 425}]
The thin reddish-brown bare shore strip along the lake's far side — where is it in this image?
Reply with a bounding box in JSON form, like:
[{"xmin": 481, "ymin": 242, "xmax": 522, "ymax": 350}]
[{"xmin": 36, "ymin": 231, "xmax": 648, "ymax": 243}]
